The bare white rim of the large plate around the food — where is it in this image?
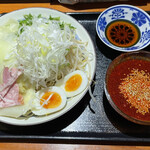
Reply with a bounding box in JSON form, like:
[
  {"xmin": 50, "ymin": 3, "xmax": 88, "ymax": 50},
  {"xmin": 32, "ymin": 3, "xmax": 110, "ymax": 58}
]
[{"xmin": 0, "ymin": 8, "xmax": 96, "ymax": 126}]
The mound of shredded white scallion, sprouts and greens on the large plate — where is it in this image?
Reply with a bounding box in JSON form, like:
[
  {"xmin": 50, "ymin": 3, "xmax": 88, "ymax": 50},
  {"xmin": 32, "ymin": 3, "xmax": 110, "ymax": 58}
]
[{"xmin": 15, "ymin": 14, "xmax": 89, "ymax": 88}]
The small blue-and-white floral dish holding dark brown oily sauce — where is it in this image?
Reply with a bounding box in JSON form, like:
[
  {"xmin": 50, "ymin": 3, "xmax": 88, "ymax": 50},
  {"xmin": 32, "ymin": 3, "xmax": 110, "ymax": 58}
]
[{"xmin": 96, "ymin": 5, "xmax": 150, "ymax": 52}]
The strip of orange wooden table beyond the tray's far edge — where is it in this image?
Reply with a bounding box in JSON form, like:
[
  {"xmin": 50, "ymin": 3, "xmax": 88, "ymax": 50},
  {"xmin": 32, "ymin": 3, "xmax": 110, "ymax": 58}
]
[{"xmin": 0, "ymin": 0, "xmax": 150, "ymax": 13}]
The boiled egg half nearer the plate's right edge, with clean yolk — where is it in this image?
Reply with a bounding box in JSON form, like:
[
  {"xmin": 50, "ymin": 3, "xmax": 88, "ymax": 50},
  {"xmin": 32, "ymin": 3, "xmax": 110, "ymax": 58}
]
[{"xmin": 61, "ymin": 70, "xmax": 88, "ymax": 97}]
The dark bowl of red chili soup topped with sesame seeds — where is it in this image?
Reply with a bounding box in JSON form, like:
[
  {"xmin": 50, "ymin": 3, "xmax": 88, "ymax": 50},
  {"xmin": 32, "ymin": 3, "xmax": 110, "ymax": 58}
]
[{"xmin": 104, "ymin": 51, "xmax": 150, "ymax": 125}]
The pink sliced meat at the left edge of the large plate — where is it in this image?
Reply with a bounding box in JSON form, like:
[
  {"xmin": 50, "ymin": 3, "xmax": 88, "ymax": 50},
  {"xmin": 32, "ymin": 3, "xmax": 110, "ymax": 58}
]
[{"xmin": 0, "ymin": 67, "xmax": 23, "ymax": 108}]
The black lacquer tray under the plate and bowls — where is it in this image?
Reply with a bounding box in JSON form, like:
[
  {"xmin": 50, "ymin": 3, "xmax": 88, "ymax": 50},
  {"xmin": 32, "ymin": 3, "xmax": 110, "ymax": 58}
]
[{"xmin": 0, "ymin": 13, "xmax": 150, "ymax": 145}]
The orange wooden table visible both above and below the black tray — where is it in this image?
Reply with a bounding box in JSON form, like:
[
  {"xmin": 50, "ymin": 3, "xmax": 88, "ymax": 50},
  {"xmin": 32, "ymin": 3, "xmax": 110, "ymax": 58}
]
[{"xmin": 0, "ymin": 0, "xmax": 150, "ymax": 150}]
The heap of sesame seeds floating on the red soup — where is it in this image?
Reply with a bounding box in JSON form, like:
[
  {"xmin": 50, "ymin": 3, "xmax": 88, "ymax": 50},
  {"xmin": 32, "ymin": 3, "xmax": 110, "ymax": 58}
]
[{"xmin": 119, "ymin": 69, "xmax": 150, "ymax": 115}]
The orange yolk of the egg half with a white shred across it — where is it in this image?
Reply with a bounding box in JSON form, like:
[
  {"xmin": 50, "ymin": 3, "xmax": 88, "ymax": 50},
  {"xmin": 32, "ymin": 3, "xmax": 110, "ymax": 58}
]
[{"xmin": 40, "ymin": 92, "xmax": 62, "ymax": 109}]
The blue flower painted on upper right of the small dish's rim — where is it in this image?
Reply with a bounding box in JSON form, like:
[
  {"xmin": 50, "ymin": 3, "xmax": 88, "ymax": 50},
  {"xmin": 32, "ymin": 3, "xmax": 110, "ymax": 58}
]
[{"xmin": 131, "ymin": 12, "xmax": 146, "ymax": 27}]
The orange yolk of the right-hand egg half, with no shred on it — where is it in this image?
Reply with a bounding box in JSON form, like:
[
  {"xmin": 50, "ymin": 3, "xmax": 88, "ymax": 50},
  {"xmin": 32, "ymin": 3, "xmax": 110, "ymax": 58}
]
[{"xmin": 65, "ymin": 74, "xmax": 82, "ymax": 92}]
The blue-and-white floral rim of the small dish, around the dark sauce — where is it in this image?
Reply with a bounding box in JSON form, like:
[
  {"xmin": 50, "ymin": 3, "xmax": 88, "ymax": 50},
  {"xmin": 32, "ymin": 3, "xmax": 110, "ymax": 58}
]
[{"xmin": 96, "ymin": 5, "xmax": 150, "ymax": 52}]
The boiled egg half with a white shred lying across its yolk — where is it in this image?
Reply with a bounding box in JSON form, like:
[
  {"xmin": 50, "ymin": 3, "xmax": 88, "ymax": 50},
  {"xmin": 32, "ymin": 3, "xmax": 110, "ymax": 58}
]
[{"xmin": 32, "ymin": 86, "xmax": 67, "ymax": 116}]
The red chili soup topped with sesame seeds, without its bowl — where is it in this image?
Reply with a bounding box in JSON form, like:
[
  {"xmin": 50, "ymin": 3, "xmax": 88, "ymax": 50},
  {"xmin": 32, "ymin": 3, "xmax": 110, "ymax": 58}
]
[{"xmin": 108, "ymin": 59, "xmax": 150, "ymax": 121}]
